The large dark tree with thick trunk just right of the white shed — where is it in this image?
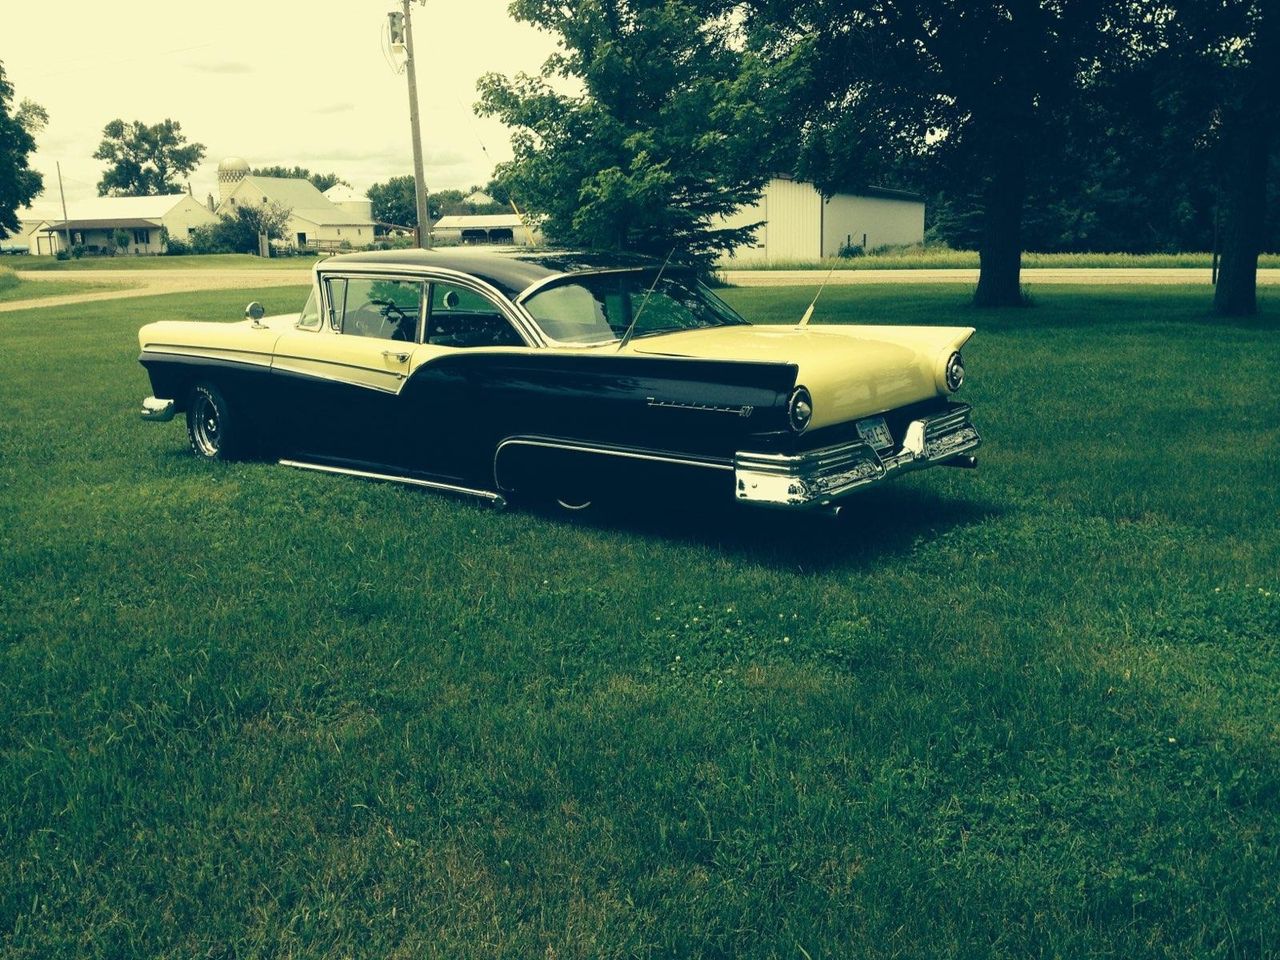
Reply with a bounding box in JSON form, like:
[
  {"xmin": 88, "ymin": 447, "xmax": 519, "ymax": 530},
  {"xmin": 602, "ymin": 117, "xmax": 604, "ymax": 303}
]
[{"xmin": 753, "ymin": 0, "xmax": 1128, "ymax": 306}]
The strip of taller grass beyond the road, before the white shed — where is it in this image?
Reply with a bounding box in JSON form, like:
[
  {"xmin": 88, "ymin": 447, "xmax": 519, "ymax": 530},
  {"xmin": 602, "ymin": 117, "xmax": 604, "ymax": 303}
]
[{"xmin": 732, "ymin": 247, "xmax": 1280, "ymax": 270}]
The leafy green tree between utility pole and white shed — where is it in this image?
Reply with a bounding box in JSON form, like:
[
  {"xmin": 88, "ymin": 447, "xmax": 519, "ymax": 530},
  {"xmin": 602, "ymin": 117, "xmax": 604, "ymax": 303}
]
[{"xmin": 477, "ymin": 0, "xmax": 777, "ymax": 264}]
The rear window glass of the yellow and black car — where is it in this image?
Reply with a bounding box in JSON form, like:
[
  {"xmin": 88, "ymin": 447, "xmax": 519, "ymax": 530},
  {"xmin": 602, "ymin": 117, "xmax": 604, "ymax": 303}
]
[{"xmin": 525, "ymin": 270, "xmax": 746, "ymax": 343}]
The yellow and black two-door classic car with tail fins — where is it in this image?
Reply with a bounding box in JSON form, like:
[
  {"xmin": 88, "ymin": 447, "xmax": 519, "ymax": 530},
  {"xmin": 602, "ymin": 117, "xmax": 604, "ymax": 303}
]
[{"xmin": 138, "ymin": 247, "xmax": 980, "ymax": 509}]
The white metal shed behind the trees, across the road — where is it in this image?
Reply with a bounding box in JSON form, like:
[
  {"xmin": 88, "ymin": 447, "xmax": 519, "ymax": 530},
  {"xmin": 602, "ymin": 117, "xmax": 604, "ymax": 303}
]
[{"xmin": 717, "ymin": 177, "xmax": 924, "ymax": 266}]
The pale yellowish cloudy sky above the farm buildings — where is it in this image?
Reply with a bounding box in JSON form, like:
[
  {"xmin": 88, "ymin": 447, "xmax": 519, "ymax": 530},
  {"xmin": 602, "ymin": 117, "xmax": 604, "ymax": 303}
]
[{"xmin": 0, "ymin": 0, "xmax": 554, "ymax": 212}]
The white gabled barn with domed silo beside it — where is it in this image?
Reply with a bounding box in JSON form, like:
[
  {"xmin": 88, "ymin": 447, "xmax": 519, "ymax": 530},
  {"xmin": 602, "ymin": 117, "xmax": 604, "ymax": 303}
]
[{"xmin": 216, "ymin": 156, "xmax": 374, "ymax": 251}]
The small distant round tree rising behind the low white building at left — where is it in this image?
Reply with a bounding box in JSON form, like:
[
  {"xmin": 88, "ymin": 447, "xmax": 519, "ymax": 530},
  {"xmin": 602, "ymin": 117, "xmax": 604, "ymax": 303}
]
[{"xmin": 93, "ymin": 119, "xmax": 205, "ymax": 197}]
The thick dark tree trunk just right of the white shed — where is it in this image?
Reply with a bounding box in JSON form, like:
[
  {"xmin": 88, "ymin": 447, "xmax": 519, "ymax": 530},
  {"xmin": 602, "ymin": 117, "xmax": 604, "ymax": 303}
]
[{"xmin": 973, "ymin": 148, "xmax": 1027, "ymax": 307}]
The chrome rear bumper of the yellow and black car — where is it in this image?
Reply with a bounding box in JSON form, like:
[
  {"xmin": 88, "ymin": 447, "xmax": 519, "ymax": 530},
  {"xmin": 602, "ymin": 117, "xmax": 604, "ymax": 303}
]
[{"xmin": 733, "ymin": 403, "xmax": 982, "ymax": 509}]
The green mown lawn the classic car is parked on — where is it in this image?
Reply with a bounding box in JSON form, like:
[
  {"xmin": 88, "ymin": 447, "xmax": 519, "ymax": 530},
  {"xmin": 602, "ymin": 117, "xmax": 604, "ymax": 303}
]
[{"xmin": 0, "ymin": 285, "xmax": 1280, "ymax": 960}]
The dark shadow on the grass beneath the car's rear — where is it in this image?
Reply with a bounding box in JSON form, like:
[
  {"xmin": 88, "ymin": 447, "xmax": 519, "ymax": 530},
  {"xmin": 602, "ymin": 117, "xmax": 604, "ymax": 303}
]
[{"xmin": 527, "ymin": 486, "xmax": 1004, "ymax": 572}]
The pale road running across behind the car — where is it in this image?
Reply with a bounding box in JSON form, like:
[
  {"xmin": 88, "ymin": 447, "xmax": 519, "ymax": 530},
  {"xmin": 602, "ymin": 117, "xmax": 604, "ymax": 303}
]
[{"xmin": 0, "ymin": 268, "xmax": 1280, "ymax": 312}]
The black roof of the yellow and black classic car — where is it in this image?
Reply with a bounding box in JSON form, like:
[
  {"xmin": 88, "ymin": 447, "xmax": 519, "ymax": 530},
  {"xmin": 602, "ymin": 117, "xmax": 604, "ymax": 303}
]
[{"xmin": 320, "ymin": 247, "xmax": 659, "ymax": 297}]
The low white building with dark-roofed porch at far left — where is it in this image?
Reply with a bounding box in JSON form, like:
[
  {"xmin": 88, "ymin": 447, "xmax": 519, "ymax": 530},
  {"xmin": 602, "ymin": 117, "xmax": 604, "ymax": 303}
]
[{"xmin": 23, "ymin": 193, "xmax": 216, "ymax": 256}]
